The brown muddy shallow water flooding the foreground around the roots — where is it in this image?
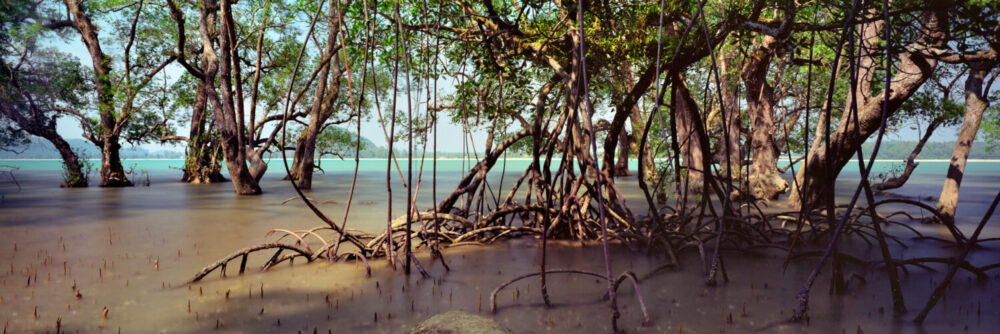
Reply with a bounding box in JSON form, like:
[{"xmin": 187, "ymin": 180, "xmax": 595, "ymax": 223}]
[{"xmin": 0, "ymin": 167, "xmax": 1000, "ymax": 333}]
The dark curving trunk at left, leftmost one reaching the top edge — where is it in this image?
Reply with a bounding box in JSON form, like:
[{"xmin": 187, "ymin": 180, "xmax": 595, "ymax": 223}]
[{"xmin": 64, "ymin": 0, "xmax": 132, "ymax": 187}]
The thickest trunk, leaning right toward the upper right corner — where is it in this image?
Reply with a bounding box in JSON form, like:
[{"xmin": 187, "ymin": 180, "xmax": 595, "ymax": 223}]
[{"xmin": 788, "ymin": 3, "xmax": 948, "ymax": 208}]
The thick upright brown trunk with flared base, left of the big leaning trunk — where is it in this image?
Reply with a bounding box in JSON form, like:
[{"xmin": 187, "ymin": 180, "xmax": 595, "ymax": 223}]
[{"xmin": 741, "ymin": 36, "xmax": 788, "ymax": 200}]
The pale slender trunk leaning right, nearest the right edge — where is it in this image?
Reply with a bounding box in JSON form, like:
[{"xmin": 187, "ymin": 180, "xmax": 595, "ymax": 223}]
[{"xmin": 938, "ymin": 62, "xmax": 992, "ymax": 223}]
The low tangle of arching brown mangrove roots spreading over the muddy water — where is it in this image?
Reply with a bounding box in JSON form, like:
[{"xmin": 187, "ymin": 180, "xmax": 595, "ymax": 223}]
[{"xmin": 191, "ymin": 176, "xmax": 1000, "ymax": 330}]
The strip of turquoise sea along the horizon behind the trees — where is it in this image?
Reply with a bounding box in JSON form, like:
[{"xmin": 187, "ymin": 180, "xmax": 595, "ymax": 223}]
[{"xmin": 0, "ymin": 159, "xmax": 1000, "ymax": 176}]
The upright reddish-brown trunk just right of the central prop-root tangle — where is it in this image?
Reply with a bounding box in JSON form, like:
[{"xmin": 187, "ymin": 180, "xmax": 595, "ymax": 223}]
[{"xmin": 671, "ymin": 74, "xmax": 705, "ymax": 193}]
